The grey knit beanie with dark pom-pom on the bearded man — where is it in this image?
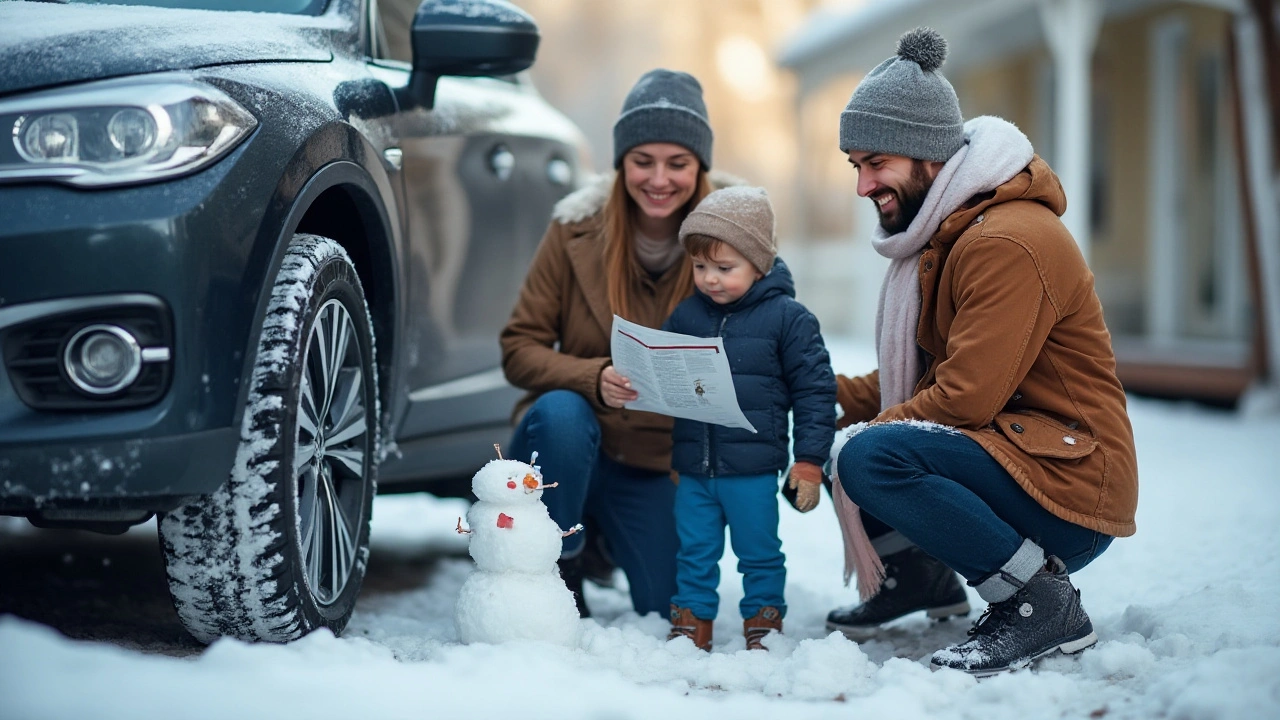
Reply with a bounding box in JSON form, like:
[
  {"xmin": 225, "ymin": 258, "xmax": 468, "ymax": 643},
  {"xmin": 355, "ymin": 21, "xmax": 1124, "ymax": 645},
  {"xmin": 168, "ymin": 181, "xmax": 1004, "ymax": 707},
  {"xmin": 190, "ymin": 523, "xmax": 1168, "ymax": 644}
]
[{"xmin": 840, "ymin": 27, "xmax": 964, "ymax": 163}]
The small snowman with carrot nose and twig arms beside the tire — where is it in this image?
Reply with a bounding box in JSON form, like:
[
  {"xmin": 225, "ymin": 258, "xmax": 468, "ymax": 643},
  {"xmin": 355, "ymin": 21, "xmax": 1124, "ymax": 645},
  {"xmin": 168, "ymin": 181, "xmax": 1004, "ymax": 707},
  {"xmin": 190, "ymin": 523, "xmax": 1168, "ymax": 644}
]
[{"xmin": 454, "ymin": 446, "xmax": 582, "ymax": 646}]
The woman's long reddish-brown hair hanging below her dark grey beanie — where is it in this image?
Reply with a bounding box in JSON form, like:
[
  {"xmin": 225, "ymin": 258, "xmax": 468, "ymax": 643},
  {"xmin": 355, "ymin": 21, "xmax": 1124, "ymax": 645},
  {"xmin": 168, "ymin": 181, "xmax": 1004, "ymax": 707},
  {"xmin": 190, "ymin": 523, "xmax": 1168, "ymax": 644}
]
[{"xmin": 604, "ymin": 168, "xmax": 713, "ymax": 320}]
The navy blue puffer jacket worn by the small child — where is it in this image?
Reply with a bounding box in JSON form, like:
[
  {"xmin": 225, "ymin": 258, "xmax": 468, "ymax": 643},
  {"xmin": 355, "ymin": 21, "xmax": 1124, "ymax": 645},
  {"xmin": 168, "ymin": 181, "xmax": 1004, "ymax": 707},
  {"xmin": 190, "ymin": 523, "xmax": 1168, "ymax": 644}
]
[{"xmin": 663, "ymin": 259, "xmax": 836, "ymax": 477}]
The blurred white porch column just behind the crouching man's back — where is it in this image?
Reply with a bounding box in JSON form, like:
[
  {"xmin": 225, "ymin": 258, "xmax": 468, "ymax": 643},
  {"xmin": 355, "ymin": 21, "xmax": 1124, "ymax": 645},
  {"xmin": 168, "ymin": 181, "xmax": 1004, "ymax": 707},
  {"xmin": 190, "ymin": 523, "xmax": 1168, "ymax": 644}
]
[{"xmin": 1039, "ymin": 0, "xmax": 1102, "ymax": 260}]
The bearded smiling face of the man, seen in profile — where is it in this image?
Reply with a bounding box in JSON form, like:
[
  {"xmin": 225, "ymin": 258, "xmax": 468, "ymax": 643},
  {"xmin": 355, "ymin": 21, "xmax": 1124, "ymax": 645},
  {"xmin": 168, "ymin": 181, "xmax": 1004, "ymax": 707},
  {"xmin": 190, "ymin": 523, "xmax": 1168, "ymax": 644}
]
[{"xmin": 849, "ymin": 150, "xmax": 942, "ymax": 234}]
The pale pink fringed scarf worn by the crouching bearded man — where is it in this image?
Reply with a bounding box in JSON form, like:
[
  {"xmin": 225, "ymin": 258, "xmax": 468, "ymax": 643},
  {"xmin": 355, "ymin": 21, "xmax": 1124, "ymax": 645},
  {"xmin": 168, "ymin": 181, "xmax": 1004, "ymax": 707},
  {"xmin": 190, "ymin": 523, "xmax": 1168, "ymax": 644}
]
[{"xmin": 831, "ymin": 115, "xmax": 1034, "ymax": 601}]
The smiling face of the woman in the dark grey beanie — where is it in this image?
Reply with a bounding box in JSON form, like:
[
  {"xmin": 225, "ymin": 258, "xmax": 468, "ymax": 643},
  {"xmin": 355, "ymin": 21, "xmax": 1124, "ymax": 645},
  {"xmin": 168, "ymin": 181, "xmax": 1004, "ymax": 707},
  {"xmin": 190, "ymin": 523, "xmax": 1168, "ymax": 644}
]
[{"xmin": 622, "ymin": 142, "xmax": 700, "ymax": 220}]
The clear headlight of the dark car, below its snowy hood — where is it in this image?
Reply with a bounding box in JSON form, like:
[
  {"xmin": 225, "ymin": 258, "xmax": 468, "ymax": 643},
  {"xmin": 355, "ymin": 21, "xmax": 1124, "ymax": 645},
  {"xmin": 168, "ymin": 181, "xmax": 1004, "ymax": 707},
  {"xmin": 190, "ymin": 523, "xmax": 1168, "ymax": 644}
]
[{"xmin": 0, "ymin": 79, "xmax": 257, "ymax": 187}]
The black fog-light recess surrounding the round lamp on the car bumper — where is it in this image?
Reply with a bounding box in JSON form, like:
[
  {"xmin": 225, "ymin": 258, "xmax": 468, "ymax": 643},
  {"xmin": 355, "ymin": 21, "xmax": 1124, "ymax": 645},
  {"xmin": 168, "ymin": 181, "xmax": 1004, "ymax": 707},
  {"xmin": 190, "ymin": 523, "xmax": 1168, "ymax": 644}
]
[{"xmin": 4, "ymin": 299, "xmax": 173, "ymax": 411}]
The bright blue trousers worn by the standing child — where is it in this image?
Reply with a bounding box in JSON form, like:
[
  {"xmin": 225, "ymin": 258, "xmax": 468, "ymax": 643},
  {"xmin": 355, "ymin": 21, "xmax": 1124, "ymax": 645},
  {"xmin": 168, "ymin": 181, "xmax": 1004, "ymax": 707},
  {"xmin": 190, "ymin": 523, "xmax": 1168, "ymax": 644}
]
[{"xmin": 671, "ymin": 473, "xmax": 787, "ymax": 620}]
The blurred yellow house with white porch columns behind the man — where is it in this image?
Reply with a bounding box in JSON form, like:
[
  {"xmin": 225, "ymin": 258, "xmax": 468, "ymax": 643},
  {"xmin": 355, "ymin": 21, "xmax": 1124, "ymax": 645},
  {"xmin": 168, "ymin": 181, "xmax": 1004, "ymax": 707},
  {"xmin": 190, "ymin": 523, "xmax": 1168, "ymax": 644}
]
[{"xmin": 780, "ymin": 0, "xmax": 1280, "ymax": 402}]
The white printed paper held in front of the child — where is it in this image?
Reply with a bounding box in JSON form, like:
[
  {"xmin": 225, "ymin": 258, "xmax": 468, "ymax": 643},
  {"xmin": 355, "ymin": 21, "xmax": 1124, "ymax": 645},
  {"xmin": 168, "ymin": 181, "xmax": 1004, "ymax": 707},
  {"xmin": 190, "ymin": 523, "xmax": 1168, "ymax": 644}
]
[{"xmin": 609, "ymin": 315, "xmax": 755, "ymax": 433}]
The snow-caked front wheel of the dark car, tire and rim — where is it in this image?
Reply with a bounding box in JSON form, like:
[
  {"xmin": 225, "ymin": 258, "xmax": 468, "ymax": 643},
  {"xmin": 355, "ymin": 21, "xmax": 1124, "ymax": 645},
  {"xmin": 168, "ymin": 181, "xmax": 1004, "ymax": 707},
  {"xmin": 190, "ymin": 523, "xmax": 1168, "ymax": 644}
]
[{"xmin": 160, "ymin": 234, "xmax": 379, "ymax": 643}]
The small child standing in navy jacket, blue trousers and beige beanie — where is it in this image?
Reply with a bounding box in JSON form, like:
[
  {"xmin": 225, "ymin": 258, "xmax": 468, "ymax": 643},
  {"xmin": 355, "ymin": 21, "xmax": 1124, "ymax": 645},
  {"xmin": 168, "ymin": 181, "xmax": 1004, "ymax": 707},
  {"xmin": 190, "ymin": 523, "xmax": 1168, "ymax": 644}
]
[{"xmin": 663, "ymin": 187, "xmax": 836, "ymax": 651}]
